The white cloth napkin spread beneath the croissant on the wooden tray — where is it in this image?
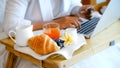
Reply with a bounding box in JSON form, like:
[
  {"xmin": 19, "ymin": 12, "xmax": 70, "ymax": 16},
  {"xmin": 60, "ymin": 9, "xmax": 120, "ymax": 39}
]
[{"xmin": 14, "ymin": 31, "xmax": 86, "ymax": 60}]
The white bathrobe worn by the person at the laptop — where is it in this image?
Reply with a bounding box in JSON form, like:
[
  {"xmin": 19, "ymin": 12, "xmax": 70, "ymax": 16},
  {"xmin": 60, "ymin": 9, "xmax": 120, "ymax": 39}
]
[{"xmin": 4, "ymin": 0, "xmax": 81, "ymax": 32}]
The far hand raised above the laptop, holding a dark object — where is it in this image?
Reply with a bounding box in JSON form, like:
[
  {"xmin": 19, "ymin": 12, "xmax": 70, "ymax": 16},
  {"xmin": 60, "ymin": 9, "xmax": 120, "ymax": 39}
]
[{"xmin": 79, "ymin": 5, "xmax": 93, "ymax": 19}]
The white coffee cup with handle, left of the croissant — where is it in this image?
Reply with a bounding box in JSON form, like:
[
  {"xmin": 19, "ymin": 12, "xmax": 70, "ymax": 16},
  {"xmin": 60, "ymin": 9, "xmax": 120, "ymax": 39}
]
[{"xmin": 9, "ymin": 25, "xmax": 33, "ymax": 46}]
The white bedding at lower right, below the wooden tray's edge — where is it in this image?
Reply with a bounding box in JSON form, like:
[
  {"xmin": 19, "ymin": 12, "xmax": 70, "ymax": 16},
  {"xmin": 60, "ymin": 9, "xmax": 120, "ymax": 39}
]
[{"xmin": 70, "ymin": 43, "xmax": 120, "ymax": 68}]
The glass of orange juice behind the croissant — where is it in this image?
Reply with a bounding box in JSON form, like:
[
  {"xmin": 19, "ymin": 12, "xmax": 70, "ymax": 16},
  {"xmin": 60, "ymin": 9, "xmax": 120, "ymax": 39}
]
[{"xmin": 43, "ymin": 22, "xmax": 60, "ymax": 39}]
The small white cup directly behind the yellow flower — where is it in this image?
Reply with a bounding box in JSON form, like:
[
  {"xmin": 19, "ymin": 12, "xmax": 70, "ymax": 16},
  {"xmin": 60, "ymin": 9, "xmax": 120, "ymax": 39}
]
[{"xmin": 65, "ymin": 28, "xmax": 78, "ymax": 42}]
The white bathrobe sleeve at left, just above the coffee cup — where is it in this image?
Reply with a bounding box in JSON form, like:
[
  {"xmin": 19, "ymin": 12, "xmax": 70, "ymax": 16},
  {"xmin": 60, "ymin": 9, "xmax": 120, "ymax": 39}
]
[{"xmin": 4, "ymin": 0, "xmax": 31, "ymax": 33}]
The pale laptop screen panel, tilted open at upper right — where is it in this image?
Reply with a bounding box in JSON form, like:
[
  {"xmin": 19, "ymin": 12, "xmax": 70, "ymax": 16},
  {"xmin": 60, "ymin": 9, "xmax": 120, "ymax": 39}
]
[{"xmin": 92, "ymin": 0, "xmax": 120, "ymax": 36}]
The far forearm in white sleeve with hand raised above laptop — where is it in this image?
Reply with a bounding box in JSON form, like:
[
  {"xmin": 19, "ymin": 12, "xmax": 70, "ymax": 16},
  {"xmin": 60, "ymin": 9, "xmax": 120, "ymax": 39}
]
[{"xmin": 71, "ymin": 0, "xmax": 93, "ymax": 19}]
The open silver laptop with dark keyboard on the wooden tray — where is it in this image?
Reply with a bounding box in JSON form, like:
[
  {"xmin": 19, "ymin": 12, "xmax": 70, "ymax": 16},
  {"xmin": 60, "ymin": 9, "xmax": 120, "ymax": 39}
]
[{"xmin": 77, "ymin": 0, "xmax": 120, "ymax": 38}]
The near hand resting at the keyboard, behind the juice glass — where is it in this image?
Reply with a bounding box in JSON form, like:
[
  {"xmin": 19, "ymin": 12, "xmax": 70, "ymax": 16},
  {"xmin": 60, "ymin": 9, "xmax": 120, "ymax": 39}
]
[{"xmin": 54, "ymin": 16, "xmax": 82, "ymax": 29}]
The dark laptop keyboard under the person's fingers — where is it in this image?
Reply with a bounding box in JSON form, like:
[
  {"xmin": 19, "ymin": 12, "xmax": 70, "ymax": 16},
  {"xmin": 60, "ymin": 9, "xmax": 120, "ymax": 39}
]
[{"xmin": 77, "ymin": 17, "xmax": 100, "ymax": 35}]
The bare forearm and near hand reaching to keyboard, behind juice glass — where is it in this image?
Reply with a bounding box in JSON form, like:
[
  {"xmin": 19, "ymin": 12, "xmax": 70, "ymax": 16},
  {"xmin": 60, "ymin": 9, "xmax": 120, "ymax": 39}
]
[{"xmin": 32, "ymin": 16, "xmax": 82, "ymax": 31}]
